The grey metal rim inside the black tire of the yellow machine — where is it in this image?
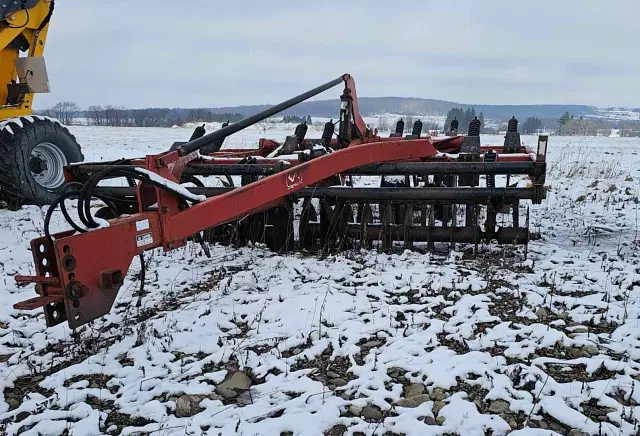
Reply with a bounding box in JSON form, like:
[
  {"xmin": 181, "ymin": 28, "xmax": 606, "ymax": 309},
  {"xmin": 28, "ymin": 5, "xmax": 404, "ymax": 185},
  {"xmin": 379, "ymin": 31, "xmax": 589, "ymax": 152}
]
[{"xmin": 29, "ymin": 142, "xmax": 68, "ymax": 189}]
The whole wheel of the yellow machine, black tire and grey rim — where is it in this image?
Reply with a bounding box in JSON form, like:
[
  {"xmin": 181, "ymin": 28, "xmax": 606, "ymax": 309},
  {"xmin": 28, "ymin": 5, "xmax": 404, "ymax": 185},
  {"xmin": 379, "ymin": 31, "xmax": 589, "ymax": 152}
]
[{"xmin": 0, "ymin": 116, "xmax": 84, "ymax": 209}]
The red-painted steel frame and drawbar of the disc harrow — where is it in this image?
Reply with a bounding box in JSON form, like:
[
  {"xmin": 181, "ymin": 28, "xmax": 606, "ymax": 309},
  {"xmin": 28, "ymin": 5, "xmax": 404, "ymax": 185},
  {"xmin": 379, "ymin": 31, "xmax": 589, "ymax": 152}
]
[{"xmin": 14, "ymin": 76, "xmax": 544, "ymax": 328}]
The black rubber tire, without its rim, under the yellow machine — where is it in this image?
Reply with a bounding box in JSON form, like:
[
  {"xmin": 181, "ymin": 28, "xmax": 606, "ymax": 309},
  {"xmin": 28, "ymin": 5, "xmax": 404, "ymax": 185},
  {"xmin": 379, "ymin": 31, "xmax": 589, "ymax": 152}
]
[{"xmin": 0, "ymin": 117, "xmax": 84, "ymax": 209}]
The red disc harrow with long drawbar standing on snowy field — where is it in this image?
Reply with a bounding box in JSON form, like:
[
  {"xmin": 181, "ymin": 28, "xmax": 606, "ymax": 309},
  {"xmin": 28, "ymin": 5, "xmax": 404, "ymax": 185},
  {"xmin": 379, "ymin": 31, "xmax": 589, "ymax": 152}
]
[{"xmin": 14, "ymin": 74, "xmax": 547, "ymax": 328}]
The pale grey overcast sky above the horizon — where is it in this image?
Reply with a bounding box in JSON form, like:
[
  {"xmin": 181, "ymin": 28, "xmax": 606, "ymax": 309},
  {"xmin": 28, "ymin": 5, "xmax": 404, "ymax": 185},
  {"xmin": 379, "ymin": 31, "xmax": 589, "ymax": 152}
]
[{"xmin": 36, "ymin": 0, "xmax": 640, "ymax": 108}]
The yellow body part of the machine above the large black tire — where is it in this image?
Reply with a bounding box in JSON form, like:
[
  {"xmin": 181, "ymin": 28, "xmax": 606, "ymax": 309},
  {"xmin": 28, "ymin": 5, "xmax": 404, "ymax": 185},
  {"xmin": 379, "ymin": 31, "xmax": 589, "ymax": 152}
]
[{"xmin": 0, "ymin": 0, "xmax": 55, "ymax": 120}]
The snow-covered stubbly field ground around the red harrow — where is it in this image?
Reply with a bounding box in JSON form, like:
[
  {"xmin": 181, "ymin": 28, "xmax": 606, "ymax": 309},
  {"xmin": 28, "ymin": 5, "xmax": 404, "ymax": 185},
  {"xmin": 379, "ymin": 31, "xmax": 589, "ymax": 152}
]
[{"xmin": 0, "ymin": 124, "xmax": 640, "ymax": 436}]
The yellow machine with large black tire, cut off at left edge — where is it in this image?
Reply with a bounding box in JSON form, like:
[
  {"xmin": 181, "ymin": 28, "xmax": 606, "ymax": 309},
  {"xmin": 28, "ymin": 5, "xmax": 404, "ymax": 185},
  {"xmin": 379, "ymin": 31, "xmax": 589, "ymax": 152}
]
[{"xmin": 0, "ymin": 0, "xmax": 84, "ymax": 208}]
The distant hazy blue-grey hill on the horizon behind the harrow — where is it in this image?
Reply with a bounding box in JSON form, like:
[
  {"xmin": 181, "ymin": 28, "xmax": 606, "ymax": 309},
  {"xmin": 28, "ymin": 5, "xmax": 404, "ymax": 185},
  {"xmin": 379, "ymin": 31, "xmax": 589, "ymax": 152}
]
[{"xmin": 211, "ymin": 97, "xmax": 596, "ymax": 120}]
